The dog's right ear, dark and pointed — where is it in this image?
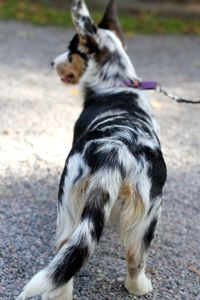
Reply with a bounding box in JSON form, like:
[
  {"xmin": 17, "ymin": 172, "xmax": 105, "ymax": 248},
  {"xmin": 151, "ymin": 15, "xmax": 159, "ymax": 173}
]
[{"xmin": 98, "ymin": 0, "xmax": 125, "ymax": 46}]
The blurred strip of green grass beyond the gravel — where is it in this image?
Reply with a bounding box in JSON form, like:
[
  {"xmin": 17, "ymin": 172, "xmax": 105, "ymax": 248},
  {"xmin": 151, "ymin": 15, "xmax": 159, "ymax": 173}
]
[{"xmin": 0, "ymin": 0, "xmax": 200, "ymax": 35}]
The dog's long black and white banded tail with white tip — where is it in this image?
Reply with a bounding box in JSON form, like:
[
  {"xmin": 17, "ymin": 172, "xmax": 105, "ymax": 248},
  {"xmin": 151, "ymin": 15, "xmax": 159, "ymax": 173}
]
[{"xmin": 17, "ymin": 187, "xmax": 115, "ymax": 300}]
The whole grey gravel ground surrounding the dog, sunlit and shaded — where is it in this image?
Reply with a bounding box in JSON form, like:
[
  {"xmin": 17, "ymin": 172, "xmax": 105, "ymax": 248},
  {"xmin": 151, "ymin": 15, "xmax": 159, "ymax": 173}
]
[{"xmin": 0, "ymin": 21, "xmax": 200, "ymax": 300}]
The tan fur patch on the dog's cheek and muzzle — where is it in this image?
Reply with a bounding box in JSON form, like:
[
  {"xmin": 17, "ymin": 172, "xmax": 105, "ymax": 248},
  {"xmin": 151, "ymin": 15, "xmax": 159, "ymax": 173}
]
[{"xmin": 57, "ymin": 54, "xmax": 85, "ymax": 84}]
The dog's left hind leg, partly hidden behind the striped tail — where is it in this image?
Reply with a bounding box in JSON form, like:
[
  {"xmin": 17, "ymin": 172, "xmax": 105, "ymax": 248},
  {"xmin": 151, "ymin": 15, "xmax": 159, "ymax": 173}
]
[{"xmin": 42, "ymin": 157, "xmax": 88, "ymax": 300}]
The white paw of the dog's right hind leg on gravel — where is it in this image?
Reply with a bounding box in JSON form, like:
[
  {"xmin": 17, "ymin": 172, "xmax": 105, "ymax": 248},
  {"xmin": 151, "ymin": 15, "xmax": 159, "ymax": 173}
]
[{"xmin": 125, "ymin": 273, "xmax": 153, "ymax": 296}]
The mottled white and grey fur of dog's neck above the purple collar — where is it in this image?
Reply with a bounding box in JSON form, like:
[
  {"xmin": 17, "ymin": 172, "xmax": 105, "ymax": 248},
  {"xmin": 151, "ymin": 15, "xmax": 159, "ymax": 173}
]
[{"xmin": 81, "ymin": 29, "xmax": 139, "ymax": 92}]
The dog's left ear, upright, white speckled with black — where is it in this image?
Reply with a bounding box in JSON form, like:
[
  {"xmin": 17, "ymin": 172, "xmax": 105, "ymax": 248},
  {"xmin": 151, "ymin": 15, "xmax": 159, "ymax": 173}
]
[{"xmin": 71, "ymin": 0, "xmax": 97, "ymax": 37}]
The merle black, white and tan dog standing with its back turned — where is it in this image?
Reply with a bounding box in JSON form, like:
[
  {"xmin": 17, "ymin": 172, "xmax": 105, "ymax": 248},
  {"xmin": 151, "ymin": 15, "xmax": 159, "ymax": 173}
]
[{"xmin": 18, "ymin": 0, "xmax": 167, "ymax": 300}]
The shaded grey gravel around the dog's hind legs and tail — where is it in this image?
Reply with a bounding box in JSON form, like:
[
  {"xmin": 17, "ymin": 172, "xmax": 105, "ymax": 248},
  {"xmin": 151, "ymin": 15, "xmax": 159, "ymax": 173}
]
[{"xmin": 0, "ymin": 164, "xmax": 200, "ymax": 300}]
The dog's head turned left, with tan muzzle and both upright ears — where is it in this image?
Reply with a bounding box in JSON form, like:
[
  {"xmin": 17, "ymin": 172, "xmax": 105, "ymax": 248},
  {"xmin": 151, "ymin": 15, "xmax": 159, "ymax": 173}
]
[{"xmin": 52, "ymin": 0, "xmax": 124, "ymax": 84}]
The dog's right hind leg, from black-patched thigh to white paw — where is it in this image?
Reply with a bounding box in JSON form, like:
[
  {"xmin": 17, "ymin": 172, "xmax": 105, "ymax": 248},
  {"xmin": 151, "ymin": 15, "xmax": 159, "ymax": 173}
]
[{"xmin": 119, "ymin": 147, "xmax": 167, "ymax": 296}]
